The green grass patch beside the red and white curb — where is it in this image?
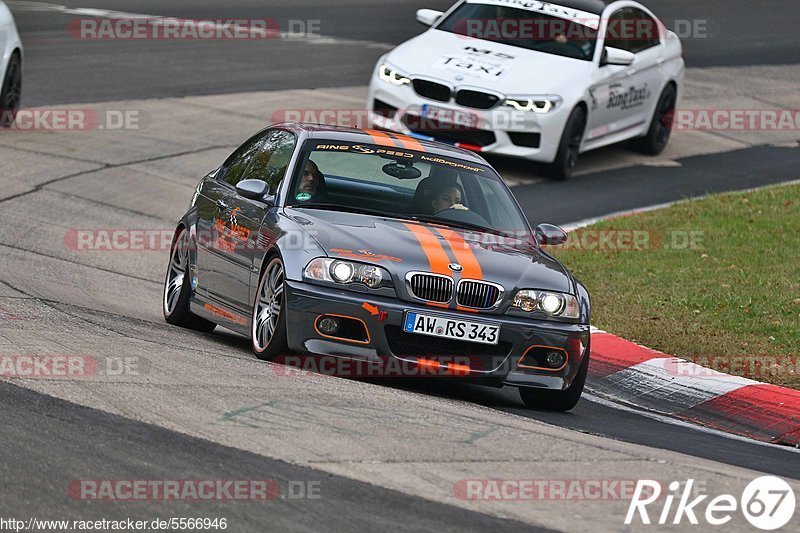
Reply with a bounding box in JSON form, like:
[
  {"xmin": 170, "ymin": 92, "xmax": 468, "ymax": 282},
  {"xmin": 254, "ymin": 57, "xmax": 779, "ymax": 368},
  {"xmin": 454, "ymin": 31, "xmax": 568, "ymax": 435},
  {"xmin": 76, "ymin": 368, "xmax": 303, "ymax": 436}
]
[{"xmin": 550, "ymin": 185, "xmax": 800, "ymax": 388}]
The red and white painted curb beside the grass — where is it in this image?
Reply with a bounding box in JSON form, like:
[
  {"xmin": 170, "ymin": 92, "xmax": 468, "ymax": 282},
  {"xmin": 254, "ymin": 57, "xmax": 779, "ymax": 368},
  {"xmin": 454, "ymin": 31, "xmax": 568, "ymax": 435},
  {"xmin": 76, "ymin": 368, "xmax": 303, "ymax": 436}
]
[{"xmin": 586, "ymin": 328, "xmax": 800, "ymax": 446}]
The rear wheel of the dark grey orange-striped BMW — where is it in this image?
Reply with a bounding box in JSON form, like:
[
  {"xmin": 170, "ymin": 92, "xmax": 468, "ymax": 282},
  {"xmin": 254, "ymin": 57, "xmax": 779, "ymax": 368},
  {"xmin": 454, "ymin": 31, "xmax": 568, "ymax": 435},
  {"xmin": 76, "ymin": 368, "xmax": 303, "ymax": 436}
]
[{"xmin": 161, "ymin": 228, "xmax": 217, "ymax": 333}]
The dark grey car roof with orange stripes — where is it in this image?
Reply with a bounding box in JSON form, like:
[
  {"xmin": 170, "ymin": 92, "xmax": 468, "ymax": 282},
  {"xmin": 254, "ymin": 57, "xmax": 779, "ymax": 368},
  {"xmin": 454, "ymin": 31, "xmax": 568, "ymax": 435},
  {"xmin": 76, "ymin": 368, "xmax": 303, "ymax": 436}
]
[{"xmin": 270, "ymin": 122, "xmax": 488, "ymax": 165}]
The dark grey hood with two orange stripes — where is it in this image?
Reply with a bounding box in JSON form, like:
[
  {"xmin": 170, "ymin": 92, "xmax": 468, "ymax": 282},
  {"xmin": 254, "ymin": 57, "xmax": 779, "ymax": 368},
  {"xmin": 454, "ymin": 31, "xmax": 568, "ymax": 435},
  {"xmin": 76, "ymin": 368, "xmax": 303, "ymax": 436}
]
[{"xmin": 286, "ymin": 209, "xmax": 573, "ymax": 294}]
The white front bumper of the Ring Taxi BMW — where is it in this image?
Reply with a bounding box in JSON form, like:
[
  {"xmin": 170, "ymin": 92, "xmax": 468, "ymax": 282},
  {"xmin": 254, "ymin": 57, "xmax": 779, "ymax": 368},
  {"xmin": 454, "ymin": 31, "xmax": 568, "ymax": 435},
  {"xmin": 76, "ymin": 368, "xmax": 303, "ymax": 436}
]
[{"xmin": 367, "ymin": 77, "xmax": 571, "ymax": 163}]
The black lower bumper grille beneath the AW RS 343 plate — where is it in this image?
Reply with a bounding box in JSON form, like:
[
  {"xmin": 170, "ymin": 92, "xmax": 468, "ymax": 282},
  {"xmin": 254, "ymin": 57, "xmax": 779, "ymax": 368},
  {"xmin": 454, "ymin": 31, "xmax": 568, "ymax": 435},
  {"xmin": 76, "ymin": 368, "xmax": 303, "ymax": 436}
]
[{"xmin": 384, "ymin": 326, "xmax": 512, "ymax": 364}]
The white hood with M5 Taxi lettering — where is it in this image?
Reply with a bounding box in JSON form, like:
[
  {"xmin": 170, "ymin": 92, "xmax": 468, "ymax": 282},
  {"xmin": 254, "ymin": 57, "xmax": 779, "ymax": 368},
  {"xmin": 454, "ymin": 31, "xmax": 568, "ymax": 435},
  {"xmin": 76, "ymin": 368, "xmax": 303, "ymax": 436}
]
[{"xmin": 386, "ymin": 29, "xmax": 592, "ymax": 95}]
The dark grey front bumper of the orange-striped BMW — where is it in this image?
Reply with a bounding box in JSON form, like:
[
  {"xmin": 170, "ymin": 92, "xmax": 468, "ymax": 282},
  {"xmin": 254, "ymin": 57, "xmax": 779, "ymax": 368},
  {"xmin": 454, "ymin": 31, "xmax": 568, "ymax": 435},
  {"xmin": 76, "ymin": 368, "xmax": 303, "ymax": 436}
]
[{"xmin": 285, "ymin": 280, "xmax": 589, "ymax": 390}]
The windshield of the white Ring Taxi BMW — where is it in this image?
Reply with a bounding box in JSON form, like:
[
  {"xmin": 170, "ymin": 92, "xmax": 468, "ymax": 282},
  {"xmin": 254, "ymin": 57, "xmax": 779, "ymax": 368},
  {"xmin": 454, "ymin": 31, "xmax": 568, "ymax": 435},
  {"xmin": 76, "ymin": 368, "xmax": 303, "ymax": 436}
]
[{"xmin": 436, "ymin": 0, "xmax": 600, "ymax": 61}]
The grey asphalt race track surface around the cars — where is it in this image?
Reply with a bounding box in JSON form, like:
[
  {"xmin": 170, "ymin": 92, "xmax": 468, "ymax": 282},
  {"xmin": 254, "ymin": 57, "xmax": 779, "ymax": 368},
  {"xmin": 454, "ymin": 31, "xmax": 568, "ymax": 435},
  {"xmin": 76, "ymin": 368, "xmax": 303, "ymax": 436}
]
[{"xmin": 0, "ymin": 0, "xmax": 800, "ymax": 531}]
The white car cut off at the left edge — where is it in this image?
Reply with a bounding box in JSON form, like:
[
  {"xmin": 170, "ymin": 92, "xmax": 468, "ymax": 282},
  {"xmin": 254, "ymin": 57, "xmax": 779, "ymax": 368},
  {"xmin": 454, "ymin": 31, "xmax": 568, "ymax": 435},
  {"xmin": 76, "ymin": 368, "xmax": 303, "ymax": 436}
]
[{"xmin": 0, "ymin": 0, "xmax": 22, "ymax": 127}]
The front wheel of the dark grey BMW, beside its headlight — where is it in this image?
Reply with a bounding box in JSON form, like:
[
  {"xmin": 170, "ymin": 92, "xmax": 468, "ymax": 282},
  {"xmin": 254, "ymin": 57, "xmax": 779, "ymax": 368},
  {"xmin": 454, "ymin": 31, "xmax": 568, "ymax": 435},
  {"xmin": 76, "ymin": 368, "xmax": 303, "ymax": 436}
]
[{"xmin": 250, "ymin": 256, "xmax": 289, "ymax": 361}]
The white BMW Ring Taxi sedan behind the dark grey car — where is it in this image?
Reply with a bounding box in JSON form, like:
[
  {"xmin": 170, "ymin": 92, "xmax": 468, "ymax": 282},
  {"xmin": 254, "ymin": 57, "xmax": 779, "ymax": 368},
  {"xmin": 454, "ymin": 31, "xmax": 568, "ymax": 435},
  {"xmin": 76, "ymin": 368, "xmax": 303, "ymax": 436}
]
[{"xmin": 367, "ymin": 0, "xmax": 684, "ymax": 179}]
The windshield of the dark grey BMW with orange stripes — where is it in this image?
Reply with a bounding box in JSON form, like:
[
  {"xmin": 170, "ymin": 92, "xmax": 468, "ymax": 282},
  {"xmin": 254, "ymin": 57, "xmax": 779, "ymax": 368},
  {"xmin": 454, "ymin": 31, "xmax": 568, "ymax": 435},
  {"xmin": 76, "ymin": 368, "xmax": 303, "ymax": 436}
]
[{"xmin": 286, "ymin": 140, "xmax": 528, "ymax": 234}]
